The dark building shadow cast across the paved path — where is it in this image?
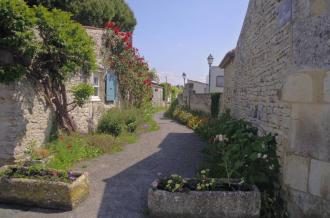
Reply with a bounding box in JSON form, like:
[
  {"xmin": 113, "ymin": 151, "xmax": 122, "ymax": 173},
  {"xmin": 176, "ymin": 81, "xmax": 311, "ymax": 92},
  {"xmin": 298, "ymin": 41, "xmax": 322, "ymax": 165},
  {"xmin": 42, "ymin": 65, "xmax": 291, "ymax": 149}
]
[{"xmin": 98, "ymin": 133, "xmax": 201, "ymax": 218}]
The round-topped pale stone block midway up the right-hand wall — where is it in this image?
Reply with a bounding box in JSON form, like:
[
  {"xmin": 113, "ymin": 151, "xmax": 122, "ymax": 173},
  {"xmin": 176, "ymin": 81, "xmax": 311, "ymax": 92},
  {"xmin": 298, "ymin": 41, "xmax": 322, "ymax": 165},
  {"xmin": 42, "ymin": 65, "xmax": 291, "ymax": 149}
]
[{"xmin": 282, "ymin": 73, "xmax": 313, "ymax": 103}]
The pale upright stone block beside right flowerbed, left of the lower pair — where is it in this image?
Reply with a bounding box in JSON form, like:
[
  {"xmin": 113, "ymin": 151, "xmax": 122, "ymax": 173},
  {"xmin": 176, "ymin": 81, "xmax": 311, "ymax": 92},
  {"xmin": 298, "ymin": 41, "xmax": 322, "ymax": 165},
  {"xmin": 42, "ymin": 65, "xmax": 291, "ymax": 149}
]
[{"xmin": 284, "ymin": 155, "xmax": 309, "ymax": 192}]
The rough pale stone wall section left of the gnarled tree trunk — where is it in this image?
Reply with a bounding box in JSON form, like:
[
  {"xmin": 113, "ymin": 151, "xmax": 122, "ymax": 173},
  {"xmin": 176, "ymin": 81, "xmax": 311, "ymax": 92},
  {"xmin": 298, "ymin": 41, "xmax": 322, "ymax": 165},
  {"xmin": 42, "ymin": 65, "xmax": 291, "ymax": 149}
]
[{"xmin": 0, "ymin": 81, "xmax": 53, "ymax": 165}]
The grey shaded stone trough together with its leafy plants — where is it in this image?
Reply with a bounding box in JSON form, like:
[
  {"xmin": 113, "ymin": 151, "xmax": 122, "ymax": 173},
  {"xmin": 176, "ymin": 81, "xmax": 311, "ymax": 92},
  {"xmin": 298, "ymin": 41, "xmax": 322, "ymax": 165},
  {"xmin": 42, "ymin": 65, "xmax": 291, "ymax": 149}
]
[{"xmin": 148, "ymin": 170, "xmax": 261, "ymax": 218}]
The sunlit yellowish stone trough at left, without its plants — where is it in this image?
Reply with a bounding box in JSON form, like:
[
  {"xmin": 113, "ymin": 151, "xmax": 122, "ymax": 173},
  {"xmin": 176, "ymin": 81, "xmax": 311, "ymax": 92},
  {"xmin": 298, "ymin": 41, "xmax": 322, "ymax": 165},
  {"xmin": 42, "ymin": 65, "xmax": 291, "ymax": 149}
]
[{"xmin": 0, "ymin": 166, "xmax": 89, "ymax": 210}]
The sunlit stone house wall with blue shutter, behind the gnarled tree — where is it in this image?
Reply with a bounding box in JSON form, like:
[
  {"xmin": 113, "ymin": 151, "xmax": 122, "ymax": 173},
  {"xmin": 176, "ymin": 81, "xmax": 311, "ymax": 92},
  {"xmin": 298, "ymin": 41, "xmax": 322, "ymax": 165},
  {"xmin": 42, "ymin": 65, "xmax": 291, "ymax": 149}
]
[{"xmin": 0, "ymin": 27, "xmax": 119, "ymax": 165}]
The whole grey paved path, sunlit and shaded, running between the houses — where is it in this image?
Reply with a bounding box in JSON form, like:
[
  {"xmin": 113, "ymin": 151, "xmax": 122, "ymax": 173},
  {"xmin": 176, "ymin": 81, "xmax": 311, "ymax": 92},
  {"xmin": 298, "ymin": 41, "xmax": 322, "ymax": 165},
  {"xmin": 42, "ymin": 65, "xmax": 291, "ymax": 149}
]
[{"xmin": 0, "ymin": 114, "xmax": 203, "ymax": 218}]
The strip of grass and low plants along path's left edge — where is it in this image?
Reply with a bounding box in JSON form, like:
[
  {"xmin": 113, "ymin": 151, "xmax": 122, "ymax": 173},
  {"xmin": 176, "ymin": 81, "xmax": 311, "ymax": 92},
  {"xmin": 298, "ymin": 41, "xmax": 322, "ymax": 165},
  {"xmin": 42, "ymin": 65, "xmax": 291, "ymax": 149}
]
[{"xmin": 29, "ymin": 108, "xmax": 163, "ymax": 171}]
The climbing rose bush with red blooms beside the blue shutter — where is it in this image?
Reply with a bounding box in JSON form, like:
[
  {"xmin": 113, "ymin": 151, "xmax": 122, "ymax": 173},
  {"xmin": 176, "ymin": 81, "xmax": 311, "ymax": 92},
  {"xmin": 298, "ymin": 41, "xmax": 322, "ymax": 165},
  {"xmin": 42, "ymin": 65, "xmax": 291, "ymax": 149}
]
[{"xmin": 103, "ymin": 22, "xmax": 156, "ymax": 107}]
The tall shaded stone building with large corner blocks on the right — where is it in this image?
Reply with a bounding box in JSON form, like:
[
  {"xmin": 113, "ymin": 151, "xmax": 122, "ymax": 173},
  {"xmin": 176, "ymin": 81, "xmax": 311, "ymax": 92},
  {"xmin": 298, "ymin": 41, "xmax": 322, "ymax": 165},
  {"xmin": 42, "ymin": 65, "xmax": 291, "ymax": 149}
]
[{"xmin": 220, "ymin": 0, "xmax": 330, "ymax": 218}]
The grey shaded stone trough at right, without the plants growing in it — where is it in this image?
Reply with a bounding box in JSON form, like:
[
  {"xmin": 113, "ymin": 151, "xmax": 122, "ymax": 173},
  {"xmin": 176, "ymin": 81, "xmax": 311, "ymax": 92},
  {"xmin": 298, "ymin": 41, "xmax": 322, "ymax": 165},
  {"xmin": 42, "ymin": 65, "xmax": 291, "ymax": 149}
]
[{"xmin": 148, "ymin": 181, "xmax": 261, "ymax": 218}]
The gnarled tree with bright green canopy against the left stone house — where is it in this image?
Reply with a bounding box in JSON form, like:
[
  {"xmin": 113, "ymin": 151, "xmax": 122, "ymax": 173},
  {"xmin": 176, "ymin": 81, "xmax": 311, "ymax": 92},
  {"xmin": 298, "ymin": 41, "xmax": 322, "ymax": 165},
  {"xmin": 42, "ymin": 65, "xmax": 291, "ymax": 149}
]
[{"xmin": 0, "ymin": 0, "xmax": 96, "ymax": 131}]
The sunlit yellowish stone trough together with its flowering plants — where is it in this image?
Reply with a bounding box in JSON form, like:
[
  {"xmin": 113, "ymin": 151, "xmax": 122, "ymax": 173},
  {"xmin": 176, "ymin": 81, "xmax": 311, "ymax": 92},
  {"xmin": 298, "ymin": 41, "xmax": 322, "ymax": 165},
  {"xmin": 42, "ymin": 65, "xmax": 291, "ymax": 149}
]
[{"xmin": 0, "ymin": 165, "xmax": 89, "ymax": 210}]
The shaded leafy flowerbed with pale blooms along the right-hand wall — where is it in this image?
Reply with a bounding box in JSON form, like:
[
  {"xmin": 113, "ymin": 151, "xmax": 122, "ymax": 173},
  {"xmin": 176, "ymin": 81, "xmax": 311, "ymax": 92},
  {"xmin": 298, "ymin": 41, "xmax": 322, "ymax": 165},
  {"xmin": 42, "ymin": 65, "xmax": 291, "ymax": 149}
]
[{"xmin": 167, "ymin": 103, "xmax": 287, "ymax": 217}]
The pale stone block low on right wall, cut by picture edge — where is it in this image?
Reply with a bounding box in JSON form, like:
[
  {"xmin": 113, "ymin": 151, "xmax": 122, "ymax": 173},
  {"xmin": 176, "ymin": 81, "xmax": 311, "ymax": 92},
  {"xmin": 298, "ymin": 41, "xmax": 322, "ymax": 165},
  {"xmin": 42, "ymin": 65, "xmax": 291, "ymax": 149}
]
[{"xmin": 308, "ymin": 159, "xmax": 330, "ymax": 200}]
